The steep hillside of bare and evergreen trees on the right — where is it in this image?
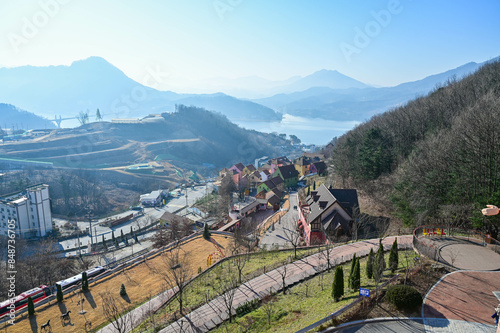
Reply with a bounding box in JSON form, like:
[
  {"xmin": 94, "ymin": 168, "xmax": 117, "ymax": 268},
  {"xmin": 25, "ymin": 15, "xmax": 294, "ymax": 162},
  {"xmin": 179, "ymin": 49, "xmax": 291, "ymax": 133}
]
[{"xmin": 331, "ymin": 61, "xmax": 500, "ymax": 231}]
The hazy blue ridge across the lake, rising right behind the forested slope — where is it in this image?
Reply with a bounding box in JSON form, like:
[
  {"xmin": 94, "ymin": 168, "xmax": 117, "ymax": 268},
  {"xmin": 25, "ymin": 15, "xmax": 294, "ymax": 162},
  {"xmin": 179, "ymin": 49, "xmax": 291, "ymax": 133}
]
[{"xmin": 253, "ymin": 58, "xmax": 498, "ymax": 121}]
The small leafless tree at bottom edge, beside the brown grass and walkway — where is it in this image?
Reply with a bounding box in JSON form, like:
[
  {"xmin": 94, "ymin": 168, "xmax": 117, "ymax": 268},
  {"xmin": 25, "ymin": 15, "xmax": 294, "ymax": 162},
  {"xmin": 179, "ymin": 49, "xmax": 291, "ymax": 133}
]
[{"xmin": 99, "ymin": 290, "xmax": 133, "ymax": 333}]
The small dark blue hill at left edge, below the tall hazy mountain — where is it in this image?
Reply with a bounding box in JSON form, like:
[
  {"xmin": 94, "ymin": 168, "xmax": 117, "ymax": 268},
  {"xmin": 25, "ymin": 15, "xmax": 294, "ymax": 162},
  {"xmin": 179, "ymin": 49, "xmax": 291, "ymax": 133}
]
[{"xmin": 0, "ymin": 103, "xmax": 56, "ymax": 129}]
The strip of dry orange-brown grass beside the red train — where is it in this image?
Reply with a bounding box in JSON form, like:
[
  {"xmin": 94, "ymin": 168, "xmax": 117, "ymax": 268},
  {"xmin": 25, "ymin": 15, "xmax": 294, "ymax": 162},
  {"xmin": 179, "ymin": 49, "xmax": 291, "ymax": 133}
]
[{"xmin": 4, "ymin": 235, "xmax": 232, "ymax": 333}]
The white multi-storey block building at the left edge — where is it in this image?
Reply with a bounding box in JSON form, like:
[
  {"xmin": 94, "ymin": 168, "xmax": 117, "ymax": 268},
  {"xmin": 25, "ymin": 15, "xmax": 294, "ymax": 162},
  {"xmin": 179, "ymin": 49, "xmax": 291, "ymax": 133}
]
[{"xmin": 0, "ymin": 184, "xmax": 52, "ymax": 238}]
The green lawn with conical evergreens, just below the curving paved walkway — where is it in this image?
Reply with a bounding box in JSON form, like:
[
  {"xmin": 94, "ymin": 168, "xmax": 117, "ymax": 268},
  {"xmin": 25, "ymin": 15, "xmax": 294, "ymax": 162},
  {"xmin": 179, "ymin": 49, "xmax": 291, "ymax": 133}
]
[{"xmin": 215, "ymin": 251, "xmax": 415, "ymax": 333}]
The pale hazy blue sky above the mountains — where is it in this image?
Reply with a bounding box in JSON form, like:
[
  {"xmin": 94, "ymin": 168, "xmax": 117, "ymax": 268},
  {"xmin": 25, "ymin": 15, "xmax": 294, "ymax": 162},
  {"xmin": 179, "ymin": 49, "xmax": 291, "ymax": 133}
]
[{"xmin": 0, "ymin": 0, "xmax": 500, "ymax": 88}]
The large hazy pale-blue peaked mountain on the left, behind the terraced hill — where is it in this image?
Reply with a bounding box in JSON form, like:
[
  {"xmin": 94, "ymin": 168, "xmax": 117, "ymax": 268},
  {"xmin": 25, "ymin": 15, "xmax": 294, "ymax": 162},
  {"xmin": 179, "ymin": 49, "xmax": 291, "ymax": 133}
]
[{"xmin": 0, "ymin": 57, "xmax": 281, "ymax": 125}]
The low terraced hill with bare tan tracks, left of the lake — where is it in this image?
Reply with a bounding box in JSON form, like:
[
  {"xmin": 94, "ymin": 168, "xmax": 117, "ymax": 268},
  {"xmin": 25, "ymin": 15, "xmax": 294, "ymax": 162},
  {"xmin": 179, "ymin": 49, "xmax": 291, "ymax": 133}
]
[{"xmin": 0, "ymin": 105, "xmax": 290, "ymax": 169}]
